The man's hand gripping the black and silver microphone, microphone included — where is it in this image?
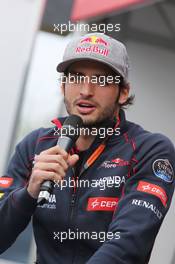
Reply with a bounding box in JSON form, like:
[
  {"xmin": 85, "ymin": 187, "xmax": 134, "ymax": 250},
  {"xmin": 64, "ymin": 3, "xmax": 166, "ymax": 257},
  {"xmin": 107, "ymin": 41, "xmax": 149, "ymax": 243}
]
[{"xmin": 27, "ymin": 115, "xmax": 83, "ymax": 204}]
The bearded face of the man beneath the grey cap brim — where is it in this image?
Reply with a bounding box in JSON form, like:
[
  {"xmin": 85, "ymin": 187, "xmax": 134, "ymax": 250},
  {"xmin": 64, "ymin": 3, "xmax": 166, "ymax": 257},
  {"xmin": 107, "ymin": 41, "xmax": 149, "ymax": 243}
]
[{"xmin": 62, "ymin": 60, "xmax": 128, "ymax": 126}]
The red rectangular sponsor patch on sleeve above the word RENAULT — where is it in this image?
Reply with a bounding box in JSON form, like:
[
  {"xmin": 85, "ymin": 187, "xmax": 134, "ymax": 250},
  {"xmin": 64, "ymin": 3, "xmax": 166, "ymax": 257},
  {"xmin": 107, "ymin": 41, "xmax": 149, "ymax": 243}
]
[{"xmin": 137, "ymin": 181, "xmax": 168, "ymax": 207}]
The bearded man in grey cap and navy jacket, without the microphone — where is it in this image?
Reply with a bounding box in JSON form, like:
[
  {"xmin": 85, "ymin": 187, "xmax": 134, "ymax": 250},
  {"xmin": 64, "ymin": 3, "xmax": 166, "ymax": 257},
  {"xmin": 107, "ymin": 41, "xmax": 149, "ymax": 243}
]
[{"xmin": 0, "ymin": 33, "xmax": 175, "ymax": 264}]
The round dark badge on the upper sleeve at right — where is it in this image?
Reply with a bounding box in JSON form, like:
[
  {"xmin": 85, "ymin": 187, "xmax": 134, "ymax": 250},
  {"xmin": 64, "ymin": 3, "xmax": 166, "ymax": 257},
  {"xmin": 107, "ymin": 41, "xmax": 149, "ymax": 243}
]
[{"xmin": 152, "ymin": 159, "xmax": 174, "ymax": 183}]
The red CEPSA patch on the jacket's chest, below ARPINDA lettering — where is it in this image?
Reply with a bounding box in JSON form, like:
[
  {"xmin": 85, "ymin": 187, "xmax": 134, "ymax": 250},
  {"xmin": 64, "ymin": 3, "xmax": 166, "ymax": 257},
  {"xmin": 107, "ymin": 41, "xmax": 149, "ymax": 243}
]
[{"xmin": 87, "ymin": 197, "xmax": 119, "ymax": 211}]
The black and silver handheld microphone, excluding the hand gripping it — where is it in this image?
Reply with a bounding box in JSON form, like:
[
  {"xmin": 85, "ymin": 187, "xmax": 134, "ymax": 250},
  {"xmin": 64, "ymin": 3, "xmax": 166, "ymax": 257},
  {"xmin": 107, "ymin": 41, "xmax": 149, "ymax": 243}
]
[{"xmin": 37, "ymin": 115, "xmax": 83, "ymax": 205}]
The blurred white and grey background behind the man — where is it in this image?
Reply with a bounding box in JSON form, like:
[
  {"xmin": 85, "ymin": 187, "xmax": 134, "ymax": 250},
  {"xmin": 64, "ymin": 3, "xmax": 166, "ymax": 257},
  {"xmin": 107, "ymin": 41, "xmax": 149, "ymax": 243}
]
[{"xmin": 0, "ymin": 0, "xmax": 175, "ymax": 264}]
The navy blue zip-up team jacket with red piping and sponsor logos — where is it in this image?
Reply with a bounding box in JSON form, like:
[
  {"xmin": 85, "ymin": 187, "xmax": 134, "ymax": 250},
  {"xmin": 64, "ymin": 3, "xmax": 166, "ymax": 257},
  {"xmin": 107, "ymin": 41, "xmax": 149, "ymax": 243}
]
[{"xmin": 0, "ymin": 110, "xmax": 175, "ymax": 264}]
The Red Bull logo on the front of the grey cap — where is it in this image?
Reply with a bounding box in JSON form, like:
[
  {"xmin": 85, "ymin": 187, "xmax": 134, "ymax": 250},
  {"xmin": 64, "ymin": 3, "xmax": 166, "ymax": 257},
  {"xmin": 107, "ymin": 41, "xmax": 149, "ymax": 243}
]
[{"xmin": 76, "ymin": 36, "xmax": 109, "ymax": 56}]
